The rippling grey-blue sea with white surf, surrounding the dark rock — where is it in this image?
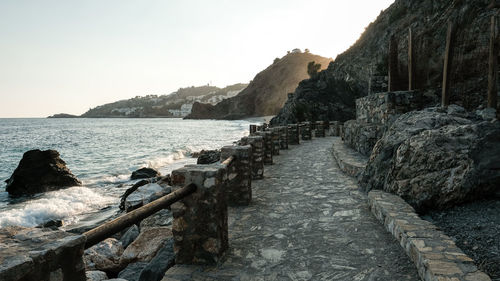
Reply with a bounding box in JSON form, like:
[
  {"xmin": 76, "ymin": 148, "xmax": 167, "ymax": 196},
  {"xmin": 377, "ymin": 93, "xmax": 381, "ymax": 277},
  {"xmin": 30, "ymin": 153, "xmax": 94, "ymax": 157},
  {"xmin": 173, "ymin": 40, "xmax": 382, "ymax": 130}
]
[{"xmin": 0, "ymin": 118, "xmax": 251, "ymax": 229}]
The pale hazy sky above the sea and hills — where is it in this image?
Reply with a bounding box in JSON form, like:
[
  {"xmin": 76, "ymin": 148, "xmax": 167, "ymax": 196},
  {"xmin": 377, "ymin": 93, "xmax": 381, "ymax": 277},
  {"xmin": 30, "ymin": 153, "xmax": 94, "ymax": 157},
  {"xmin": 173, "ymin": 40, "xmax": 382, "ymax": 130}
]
[{"xmin": 0, "ymin": 0, "xmax": 394, "ymax": 117}]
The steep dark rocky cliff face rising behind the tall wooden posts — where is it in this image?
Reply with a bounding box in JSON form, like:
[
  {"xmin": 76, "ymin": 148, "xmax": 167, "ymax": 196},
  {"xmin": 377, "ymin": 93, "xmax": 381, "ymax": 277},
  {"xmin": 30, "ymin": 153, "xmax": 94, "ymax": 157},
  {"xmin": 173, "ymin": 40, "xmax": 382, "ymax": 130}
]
[{"xmin": 271, "ymin": 0, "xmax": 496, "ymax": 124}]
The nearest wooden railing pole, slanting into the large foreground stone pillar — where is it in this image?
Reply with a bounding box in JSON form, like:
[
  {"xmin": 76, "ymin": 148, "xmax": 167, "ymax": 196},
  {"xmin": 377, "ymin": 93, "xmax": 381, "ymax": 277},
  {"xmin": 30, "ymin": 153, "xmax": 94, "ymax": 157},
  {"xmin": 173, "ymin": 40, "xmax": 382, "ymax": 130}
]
[{"xmin": 83, "ymin": 184, "xmax": 196, "ymax": 249}]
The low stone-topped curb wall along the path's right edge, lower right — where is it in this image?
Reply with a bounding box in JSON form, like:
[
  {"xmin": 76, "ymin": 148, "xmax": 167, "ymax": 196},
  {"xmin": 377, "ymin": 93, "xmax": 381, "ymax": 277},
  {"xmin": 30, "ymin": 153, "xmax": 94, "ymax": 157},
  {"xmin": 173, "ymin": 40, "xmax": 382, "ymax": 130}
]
[{"xmin": 368, "ymin": 190, "xmax": 491, "ymax": 281}]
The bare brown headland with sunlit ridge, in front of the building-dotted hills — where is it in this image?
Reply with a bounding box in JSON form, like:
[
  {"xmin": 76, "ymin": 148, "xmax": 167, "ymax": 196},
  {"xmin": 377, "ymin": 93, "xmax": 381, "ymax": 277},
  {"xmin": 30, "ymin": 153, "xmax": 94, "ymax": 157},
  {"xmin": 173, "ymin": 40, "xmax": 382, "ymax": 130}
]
[{"xmin": 186, "ymin": 52, "xmax": 331, "ymax": 119}]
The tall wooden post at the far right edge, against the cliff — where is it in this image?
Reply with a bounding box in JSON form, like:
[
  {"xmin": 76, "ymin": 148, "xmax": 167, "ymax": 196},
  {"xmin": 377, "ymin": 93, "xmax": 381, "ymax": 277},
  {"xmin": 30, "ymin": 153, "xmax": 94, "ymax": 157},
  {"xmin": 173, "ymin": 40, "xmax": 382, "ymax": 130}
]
[{"xmin": 488, "ymin": 16, "xmax": 498, "ymax": 109}]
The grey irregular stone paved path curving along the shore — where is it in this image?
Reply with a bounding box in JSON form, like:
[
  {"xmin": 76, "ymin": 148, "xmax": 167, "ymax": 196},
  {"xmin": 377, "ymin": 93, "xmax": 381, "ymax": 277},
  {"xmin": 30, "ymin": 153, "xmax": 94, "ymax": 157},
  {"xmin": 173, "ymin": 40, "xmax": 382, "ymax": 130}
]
[{"xmin": 163, "ymin": 138, "xmax": 419, "ymax": 281}]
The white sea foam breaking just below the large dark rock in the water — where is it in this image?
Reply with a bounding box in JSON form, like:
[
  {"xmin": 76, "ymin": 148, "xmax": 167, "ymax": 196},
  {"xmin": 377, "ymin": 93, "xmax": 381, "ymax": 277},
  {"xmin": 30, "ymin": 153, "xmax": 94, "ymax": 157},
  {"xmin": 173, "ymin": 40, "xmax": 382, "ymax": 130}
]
[{"xmin": 0, "ymin": 186, "xmax": 117, "ymax": 227}]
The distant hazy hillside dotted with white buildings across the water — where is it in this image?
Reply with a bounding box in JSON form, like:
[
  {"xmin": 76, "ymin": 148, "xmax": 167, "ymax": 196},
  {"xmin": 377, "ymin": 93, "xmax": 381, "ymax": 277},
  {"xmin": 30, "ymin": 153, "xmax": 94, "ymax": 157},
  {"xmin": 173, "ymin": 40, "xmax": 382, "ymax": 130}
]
[{"xmin": 81, "ymin": 84, "xmax": 247, "ymax": 118}]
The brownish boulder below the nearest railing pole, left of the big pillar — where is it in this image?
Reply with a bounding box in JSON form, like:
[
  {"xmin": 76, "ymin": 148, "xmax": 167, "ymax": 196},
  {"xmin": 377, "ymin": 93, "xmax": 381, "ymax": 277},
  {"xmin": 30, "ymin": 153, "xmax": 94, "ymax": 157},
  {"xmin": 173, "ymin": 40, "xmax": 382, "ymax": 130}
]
[{"xmin": 121, "ymin": 227, "xmax": 172, "ymax": 264}]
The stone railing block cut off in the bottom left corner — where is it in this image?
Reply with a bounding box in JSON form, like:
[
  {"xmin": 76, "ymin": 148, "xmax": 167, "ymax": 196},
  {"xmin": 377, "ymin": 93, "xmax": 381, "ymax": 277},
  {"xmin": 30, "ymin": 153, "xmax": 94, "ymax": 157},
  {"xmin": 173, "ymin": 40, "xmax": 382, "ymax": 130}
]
[{"xmin": 0, "ymin": 227, "xmax": 86, "ymax": 281}]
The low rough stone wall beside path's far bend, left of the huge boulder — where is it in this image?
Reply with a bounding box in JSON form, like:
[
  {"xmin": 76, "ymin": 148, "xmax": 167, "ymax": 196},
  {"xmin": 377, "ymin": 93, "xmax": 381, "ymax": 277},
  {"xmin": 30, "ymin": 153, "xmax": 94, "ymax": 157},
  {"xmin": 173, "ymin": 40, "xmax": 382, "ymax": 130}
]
[{"xmin": 341, "ymin": 120, "xmax": 386, "ymax": 156}]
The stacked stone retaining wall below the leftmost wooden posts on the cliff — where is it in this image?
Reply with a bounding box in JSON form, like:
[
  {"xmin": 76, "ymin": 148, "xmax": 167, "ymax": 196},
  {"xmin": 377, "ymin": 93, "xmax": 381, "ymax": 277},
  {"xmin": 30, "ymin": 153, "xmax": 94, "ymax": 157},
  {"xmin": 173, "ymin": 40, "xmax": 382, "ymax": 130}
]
[{"xmin": 356, "ymin": 91, "xmax": 422, "ymax": 124}]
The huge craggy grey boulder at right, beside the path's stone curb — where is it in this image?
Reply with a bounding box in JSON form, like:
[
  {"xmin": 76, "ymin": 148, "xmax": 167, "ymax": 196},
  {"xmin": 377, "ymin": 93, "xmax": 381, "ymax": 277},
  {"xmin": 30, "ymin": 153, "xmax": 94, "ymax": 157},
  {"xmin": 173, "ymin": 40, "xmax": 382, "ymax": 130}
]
[{"xmin": 361, "ymin": 108, "xmax": 500, "ymax": 213}]
